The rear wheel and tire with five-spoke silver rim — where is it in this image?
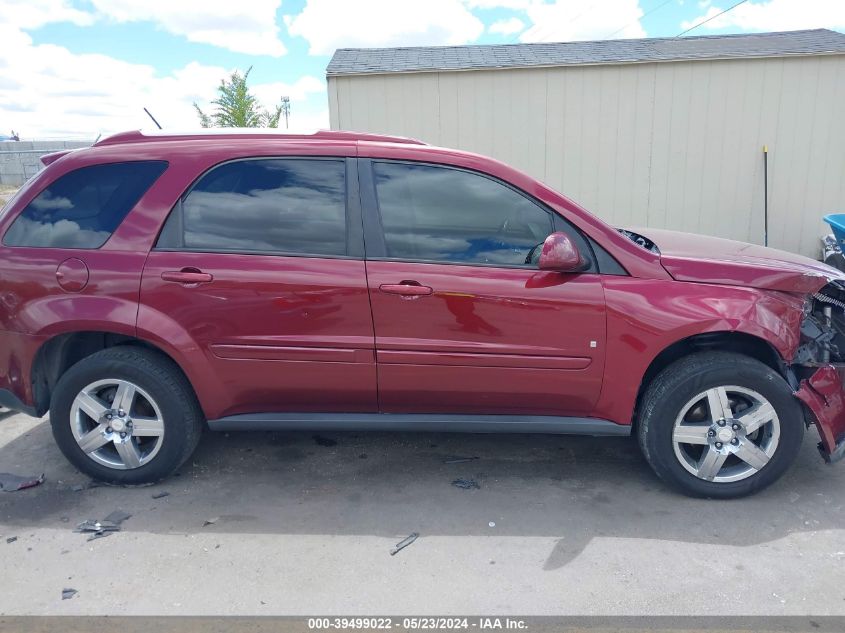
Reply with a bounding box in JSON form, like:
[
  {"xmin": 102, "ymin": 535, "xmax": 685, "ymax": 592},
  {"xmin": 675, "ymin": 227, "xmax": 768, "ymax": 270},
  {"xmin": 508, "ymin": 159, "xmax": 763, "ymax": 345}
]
[{"xmin": 50, "ymin": 346, "xmax": 203, "ymax": 485}]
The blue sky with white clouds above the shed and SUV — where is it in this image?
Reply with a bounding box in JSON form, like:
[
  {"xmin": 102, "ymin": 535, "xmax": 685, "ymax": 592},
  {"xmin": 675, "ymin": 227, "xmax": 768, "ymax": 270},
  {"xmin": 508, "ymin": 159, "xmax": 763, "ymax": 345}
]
[{"xmin": 0, "ymin": 0, "xmax": 845, "ymax": 139}]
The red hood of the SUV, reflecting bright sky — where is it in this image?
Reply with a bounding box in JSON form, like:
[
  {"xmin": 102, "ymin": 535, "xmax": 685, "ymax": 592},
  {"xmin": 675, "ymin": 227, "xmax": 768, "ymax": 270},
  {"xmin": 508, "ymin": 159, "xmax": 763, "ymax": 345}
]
[{"xmin": 631, "ymin": 229, "xmax": 845, "ymax": 294}]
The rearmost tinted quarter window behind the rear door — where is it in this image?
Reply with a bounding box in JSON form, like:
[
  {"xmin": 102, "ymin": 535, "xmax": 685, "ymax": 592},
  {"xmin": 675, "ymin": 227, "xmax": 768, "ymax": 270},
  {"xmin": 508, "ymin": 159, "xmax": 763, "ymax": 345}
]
[{"xmin": 3, "ymin": 161, "xmax": 167, "ymax": 249}]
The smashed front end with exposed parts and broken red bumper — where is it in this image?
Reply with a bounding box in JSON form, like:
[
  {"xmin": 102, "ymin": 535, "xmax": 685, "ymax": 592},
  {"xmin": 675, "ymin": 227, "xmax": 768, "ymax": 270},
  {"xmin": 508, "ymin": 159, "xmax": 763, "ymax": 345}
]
[{"xmin": 791, "ymin": 280, "xmax": 845, "ymax": 462}]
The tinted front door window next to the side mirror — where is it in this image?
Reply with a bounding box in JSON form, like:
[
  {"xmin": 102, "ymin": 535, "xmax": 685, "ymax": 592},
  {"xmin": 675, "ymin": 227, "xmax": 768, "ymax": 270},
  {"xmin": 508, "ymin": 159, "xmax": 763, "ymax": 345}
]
[{"xmin": 373, "ymin": 162, "xmax": 554, "ymax": 266}]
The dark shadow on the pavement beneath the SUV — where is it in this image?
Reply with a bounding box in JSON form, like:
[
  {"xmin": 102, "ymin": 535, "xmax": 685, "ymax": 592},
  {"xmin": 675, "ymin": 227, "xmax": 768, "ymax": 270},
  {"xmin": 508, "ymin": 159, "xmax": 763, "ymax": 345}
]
[{"xmin": 0, "ymin": 422, "xmax": 845, "ymax": 570}]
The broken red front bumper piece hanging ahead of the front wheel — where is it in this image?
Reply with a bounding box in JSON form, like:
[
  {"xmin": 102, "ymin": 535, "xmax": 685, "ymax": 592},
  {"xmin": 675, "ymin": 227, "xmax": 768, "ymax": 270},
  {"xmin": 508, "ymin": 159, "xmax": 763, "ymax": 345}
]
[{"xmin": 795, "ymin": 365, "xmax": 845, "ymax": 463}]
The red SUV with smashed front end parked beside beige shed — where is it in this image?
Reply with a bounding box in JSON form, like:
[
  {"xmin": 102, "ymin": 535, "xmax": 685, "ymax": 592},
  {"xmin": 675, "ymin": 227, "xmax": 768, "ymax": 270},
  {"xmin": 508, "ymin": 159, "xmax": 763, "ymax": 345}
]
[{"xmin": 0, "ymin": 131, "xmax": 845, "ymax": 497}]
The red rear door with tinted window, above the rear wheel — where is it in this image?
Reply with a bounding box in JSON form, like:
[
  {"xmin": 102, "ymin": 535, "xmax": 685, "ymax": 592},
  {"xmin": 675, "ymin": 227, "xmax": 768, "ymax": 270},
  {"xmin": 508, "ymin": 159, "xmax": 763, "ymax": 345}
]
[{"xmin": 138, "ymin": 158, "xmax": 376, "ymax": 417}]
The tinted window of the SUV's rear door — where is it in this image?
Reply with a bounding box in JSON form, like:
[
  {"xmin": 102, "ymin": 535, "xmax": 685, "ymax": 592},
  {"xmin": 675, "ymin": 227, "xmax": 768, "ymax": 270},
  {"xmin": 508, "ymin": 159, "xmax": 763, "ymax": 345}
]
[{"xmin": 157, "ymin": 158, "xmax": 346, "ymax": 256}]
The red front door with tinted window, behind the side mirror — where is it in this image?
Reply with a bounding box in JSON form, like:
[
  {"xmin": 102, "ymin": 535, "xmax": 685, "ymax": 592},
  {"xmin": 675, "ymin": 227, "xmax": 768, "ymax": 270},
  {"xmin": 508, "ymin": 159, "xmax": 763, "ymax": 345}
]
[{"xmin": 360, "ymin": 160, "xmax": 606, "ymax": 416}]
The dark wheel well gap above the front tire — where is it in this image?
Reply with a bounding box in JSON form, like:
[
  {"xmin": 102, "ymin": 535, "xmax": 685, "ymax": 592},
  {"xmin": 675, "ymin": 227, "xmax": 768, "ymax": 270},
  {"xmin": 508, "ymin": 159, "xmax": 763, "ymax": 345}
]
[{"xmin": 633, "ymin": 332, "xmax": 787, "ymax": 426}]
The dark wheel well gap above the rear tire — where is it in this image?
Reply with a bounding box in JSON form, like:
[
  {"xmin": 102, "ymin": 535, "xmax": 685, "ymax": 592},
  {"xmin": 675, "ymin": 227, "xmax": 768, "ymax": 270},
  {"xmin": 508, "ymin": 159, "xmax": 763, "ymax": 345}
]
[{"xmin": 32, "ymin": 331, "xmax": 190, "ymax": 416}]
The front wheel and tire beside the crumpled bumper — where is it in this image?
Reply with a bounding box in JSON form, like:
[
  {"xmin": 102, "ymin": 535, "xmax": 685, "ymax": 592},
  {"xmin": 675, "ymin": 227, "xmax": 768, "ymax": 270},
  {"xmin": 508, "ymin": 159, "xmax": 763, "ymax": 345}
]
[{"xmin": 637, "ymin": 352, "xmax": 805, "ymax": 499}]
